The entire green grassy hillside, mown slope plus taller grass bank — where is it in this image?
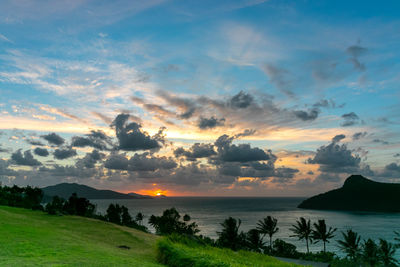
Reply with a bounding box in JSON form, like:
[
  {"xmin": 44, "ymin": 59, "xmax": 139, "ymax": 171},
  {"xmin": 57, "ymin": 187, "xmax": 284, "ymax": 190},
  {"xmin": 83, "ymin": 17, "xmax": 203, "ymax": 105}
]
[{"xmin": 0, "ymin": 206, "xmax": 298, "ymax": 267}]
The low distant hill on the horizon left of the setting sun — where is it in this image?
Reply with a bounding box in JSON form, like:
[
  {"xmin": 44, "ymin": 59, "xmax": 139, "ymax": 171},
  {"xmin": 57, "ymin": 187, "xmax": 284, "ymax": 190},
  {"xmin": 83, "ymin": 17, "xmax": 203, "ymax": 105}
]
[{"xmin": 42, "ymin": 183, "xmax": 151, "ymax": 202}]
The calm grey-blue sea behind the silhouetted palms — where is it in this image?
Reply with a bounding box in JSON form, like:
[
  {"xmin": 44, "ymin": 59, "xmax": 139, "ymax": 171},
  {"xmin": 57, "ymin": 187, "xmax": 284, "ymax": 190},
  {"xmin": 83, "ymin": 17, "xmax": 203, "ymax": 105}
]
[{"xmin": 91, "ymin": 197, "xmax": 400, "ymax": 259}]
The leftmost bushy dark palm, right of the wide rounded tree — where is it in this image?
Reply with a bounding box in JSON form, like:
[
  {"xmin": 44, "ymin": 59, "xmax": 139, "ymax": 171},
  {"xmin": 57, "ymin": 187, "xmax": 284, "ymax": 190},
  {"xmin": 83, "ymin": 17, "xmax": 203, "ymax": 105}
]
[{"xmin": 217, "ymin": 217, "xmax": 244, "ymax": 250}]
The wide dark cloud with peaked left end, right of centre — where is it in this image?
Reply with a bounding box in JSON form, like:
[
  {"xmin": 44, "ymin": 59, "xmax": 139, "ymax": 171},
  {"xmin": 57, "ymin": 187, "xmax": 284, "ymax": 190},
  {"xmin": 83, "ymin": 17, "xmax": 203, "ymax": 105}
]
[{"xmin": 215, "ymin": 135, "xmax": 274, "ymax": 162}]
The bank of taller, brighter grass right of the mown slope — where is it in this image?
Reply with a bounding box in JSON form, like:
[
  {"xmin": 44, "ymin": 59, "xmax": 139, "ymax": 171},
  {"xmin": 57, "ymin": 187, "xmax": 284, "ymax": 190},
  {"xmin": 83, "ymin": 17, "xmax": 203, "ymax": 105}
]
[{"xmin": 157, "ymin": 238, "xmax": 300, "ymax": 267}]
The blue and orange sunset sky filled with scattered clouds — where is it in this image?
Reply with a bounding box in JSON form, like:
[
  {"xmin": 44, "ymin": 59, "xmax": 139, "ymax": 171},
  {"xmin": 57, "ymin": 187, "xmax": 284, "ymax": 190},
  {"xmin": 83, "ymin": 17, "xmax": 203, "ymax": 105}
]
[{"xmin": 0, "ymin": 0, "xmax": 400, "ymax": 196}]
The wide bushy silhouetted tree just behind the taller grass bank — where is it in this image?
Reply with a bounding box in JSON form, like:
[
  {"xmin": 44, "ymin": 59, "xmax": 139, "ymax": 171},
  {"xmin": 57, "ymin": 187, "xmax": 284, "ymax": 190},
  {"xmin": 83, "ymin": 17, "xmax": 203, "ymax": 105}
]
[{"xmin": 149, "ymin": 208, "xmax": 200, "ymax": 235}]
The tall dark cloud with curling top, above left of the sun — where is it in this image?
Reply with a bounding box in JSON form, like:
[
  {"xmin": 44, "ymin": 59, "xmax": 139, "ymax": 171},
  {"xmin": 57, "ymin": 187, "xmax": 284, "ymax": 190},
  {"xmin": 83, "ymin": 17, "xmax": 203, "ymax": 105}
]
[{"xmin": 111, "ymin": 114, "xmax": 165, "ymax": 151}]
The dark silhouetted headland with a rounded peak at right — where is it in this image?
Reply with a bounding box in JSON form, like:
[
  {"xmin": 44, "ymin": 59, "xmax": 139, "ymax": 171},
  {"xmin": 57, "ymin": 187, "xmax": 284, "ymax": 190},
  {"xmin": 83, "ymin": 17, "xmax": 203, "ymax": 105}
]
[{"xmin": 298, "ymin": 175, "xmax": 400, "ymax": 212}]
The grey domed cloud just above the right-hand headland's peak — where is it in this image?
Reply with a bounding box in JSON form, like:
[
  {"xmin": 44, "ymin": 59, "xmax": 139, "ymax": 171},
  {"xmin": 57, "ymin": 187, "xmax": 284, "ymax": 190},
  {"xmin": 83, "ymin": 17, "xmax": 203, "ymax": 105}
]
[{"xmin": 307, "ymin": 143, "xmax": 361, "ymax": 173}]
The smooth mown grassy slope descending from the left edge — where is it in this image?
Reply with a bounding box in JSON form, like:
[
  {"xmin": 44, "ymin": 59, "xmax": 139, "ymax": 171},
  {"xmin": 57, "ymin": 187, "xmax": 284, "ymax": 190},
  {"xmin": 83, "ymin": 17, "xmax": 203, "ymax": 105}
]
[{"xmin": 0, "ymin": 206, "xmax": 161, "ymax": 266}]
